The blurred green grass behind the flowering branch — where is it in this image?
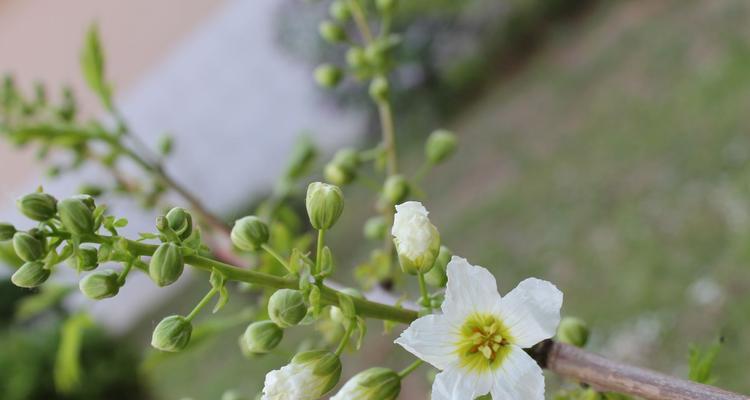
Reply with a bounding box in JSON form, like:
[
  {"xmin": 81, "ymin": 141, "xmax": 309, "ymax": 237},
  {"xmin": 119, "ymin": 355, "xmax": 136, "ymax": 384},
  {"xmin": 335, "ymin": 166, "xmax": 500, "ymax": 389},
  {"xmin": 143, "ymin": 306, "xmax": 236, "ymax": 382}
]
[{"xmin": 138, "ymin": 0, "xmax": 750, "ymax": 400}]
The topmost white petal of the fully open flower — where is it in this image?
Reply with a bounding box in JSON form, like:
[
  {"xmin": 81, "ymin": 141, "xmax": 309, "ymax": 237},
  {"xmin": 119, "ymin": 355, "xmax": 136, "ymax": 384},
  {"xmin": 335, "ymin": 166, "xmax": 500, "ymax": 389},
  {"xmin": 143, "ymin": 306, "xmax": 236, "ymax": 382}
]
[{"xmin": 442, "ymin": 256, "xmax": 500, "ymax": 324}]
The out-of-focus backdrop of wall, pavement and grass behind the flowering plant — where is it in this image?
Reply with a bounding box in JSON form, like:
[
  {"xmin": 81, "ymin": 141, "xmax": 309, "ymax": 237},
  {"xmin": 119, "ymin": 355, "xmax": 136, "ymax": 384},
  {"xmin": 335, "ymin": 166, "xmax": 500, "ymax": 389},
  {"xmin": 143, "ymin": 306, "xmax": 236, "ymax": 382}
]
[{"xmin": 0, "ymin": 0, "xmax": 750, "ymax": 400}]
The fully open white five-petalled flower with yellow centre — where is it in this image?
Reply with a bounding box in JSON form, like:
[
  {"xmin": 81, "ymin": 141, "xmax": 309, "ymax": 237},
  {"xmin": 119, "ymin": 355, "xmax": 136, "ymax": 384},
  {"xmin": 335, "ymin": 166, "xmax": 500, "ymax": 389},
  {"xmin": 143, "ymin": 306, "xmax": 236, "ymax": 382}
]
[{"xmin": 396, "ymin": 257, "xmax": 563, "ymax": 400}]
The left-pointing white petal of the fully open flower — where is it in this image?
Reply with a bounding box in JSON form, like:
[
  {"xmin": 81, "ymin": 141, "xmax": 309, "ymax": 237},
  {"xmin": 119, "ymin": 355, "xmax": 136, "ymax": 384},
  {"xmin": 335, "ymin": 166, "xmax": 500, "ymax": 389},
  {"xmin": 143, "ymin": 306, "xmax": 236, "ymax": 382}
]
[{"xmin": 395, "ymin": 314, "xmax": 458, "ymax": 369}]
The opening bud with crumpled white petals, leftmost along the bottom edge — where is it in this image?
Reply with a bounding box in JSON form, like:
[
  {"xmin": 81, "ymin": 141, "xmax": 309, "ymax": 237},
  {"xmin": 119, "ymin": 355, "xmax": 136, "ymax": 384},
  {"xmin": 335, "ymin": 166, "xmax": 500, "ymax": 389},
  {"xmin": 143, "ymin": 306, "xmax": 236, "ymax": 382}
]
[{"xmin": 263, "ymin": 350, "xmax": 341, "ymax": 400}]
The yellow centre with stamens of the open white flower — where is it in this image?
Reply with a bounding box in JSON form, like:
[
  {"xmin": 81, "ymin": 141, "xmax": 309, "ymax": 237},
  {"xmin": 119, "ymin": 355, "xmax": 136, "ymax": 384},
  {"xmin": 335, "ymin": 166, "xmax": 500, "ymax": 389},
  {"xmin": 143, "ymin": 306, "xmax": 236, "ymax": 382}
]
[{"xmin": 456, "ymin": 313, "xmax": 513, "ymax": 371}]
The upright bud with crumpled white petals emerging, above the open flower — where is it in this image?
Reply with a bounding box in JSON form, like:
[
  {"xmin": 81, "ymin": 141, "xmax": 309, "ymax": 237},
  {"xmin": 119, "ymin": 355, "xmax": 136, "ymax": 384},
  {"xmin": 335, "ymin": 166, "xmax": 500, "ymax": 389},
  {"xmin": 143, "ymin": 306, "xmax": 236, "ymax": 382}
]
[{"xmin": 391, "ymin": 201, "xmax": 440, "ymax": 274}]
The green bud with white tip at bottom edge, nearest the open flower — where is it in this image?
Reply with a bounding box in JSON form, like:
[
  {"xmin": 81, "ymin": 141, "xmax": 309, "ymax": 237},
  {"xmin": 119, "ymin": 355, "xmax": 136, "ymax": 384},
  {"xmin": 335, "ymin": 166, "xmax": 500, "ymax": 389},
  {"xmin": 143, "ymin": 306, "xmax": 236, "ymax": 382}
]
[{"xmin": 331, "ymin": 367, "xmax": 401, "ymax": 400}]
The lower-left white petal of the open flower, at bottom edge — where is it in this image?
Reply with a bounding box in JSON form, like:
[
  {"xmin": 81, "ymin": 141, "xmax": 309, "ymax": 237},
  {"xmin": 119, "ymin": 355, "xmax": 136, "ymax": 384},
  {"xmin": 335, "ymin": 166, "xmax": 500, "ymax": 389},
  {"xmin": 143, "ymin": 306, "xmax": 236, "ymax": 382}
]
[{"xmin": 432, "ymin": 366, "xmax": 494, "ymax": 400}]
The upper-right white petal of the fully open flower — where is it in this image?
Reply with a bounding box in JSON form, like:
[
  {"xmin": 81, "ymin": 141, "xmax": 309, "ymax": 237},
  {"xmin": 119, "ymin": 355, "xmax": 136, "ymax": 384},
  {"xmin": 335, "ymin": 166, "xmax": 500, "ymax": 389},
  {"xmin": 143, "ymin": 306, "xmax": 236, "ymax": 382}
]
[{"xmin": 500, "ymin": 278, "xmax": 563, "ymax": 348}]
